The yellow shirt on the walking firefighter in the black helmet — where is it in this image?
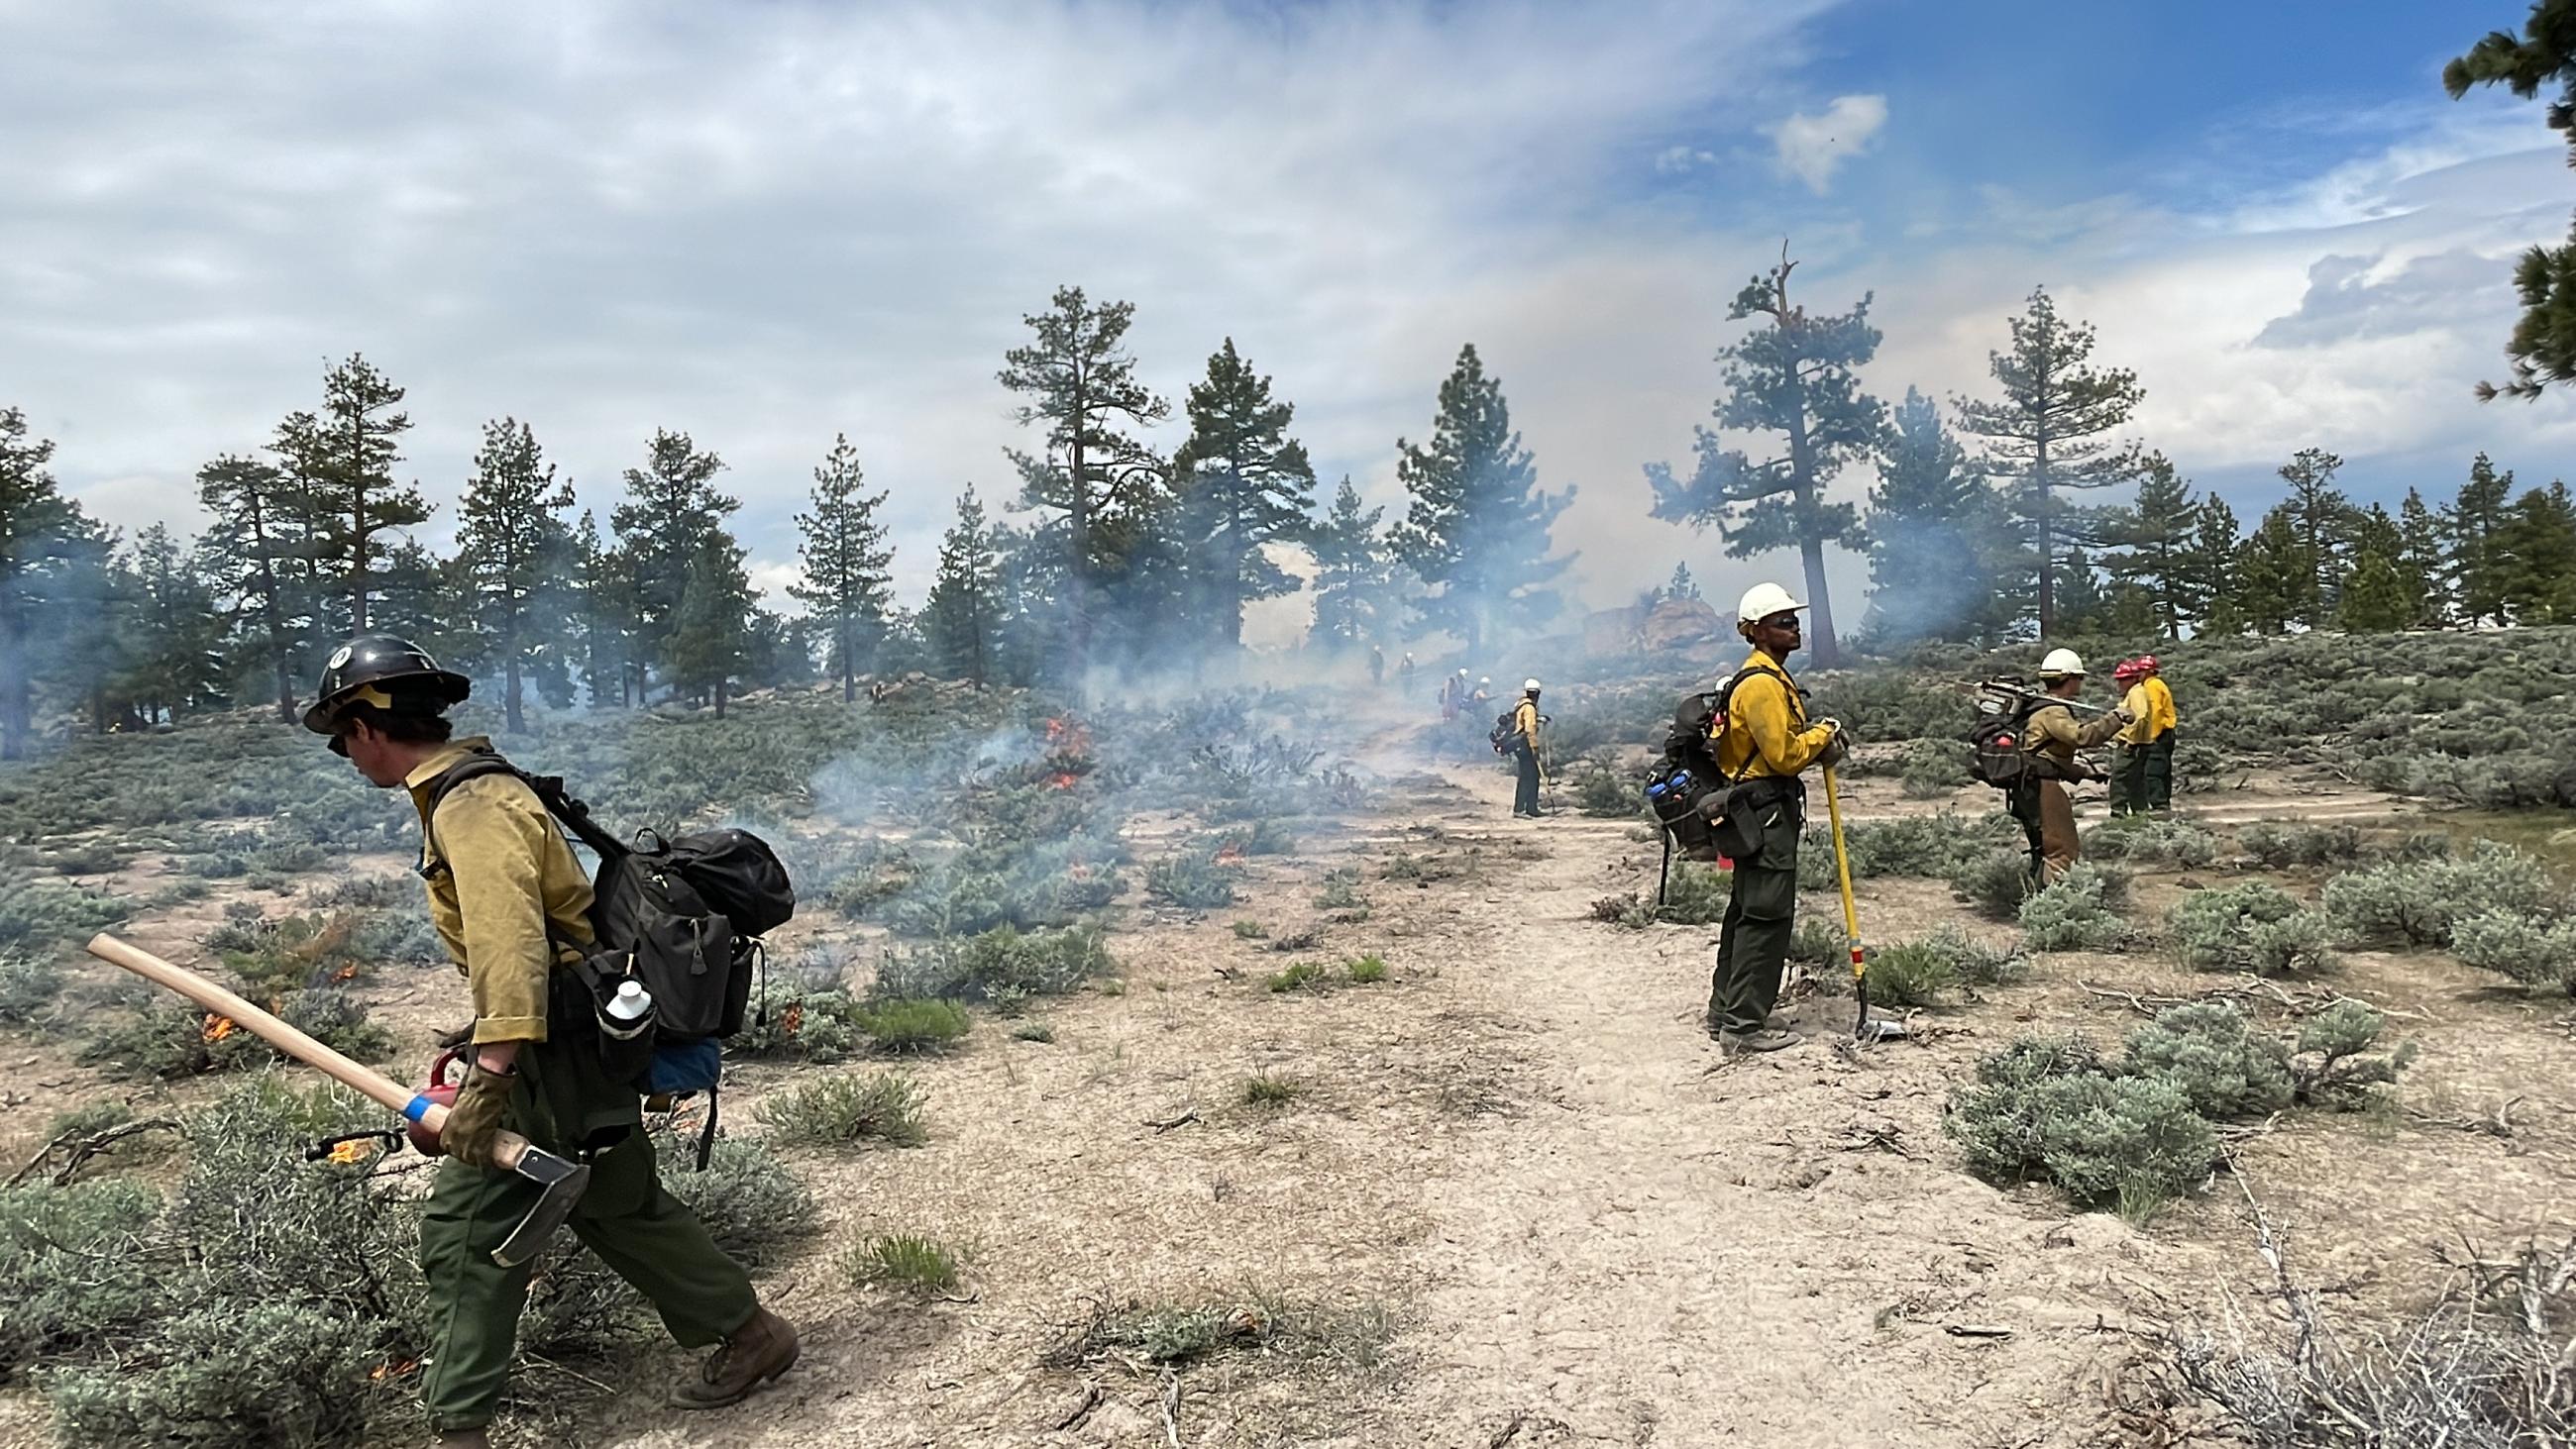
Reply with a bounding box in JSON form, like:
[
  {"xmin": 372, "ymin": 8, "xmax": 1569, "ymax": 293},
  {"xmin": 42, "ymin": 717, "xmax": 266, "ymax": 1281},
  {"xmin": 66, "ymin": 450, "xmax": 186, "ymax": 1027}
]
[{"xmin": 402, "ymin": 736, "xmax": 590, "ymax": 1042}]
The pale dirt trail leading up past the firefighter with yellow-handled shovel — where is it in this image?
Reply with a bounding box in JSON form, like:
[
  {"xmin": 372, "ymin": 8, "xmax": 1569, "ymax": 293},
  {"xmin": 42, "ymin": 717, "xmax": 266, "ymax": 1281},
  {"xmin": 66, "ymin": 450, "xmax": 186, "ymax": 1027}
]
[{"xmin": 1394, "ymin": 773, "xmax": 2187, "ymax": 1446}]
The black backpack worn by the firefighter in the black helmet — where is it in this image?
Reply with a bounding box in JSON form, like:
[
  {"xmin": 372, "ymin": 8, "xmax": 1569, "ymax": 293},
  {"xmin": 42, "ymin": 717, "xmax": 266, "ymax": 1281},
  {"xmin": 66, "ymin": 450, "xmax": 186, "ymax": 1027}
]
[{"xmin": 430, "ymin": 752, "xmax": 796, "ymax": 1169}]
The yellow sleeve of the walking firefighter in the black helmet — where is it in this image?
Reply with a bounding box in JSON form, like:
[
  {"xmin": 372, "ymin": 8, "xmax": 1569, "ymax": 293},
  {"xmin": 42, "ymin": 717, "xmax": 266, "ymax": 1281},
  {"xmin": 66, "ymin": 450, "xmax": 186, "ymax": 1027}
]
[{"xmin": 435, "ymin": 775, "xmax": 554, "ymax": 1042}]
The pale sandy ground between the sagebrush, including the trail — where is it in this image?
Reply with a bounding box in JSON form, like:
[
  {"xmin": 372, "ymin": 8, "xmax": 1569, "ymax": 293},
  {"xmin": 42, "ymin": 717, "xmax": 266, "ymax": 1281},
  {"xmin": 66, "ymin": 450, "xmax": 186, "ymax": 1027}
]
[{"xmin": 0, "ymin": 730, "xmax": 2576, "ymax": 1449}]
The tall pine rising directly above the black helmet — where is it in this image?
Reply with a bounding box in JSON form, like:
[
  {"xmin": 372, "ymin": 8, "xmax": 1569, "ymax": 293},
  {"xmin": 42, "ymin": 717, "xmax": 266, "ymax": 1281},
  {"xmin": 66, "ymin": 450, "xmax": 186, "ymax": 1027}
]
[{"xmin": 275, "ymin": 353, "xmax": 430, "ymax": 633}]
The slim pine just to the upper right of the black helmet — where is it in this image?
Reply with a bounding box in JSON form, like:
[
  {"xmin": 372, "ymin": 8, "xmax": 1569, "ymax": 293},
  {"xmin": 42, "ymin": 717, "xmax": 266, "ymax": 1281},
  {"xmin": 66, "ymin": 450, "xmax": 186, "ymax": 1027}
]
[{"xmin": 456, "ymin": 417, "xmax": 575, "ymax": 734}]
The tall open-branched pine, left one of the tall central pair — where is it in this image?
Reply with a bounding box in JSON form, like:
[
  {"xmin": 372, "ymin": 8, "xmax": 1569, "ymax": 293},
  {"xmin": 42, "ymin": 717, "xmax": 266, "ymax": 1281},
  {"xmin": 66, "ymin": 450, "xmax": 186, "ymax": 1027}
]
[{"xmin": 1000, "ymin": 285, "xmax": 1172, "ymax": 679}]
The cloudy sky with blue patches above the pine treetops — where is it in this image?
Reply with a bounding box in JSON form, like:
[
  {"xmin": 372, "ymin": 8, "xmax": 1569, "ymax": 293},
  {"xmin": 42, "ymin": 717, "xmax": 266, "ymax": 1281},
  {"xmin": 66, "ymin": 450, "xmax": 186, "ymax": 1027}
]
[{"xmin": 0, "ymin": 0, "xmax": 2576, "ymax": 638}]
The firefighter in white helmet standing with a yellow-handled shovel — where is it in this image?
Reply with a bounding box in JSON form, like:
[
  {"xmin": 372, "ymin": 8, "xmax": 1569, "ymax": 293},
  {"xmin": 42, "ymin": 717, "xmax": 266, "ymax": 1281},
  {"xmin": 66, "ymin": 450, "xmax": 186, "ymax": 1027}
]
[{"xmin": 1708, "ymin": 584, "xmax": 1850, "ymax": 1053}]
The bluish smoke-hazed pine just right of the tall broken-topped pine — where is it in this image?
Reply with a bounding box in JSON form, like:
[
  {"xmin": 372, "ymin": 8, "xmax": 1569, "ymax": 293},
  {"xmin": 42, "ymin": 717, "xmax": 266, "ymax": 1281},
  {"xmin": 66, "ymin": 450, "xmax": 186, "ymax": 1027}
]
[{"xmin": 1865, "ymin": 388, "xmax": 2032, "ymax": 641}]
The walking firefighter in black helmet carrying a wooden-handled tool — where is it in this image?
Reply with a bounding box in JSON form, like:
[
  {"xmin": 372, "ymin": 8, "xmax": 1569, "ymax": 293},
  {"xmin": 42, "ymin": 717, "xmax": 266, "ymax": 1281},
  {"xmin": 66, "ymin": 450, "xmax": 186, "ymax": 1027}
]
[{"xmin": 304, "ymin": 633, "xmax": 799, "ymax": 1449}]
